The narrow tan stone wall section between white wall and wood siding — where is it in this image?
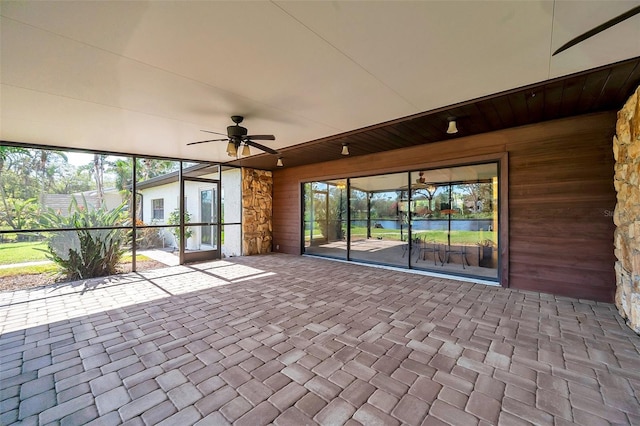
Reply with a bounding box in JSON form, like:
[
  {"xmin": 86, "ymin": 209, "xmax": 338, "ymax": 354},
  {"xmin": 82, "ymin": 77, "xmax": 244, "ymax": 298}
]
[{"xmin": 242, "ymin": 168, "xmax": 273, "ymax": 256}]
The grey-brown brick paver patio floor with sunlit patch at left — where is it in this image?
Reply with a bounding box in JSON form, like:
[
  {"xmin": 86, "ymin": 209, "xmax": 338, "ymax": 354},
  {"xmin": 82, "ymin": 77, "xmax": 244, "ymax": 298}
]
[{"xmin": 0, "ymin": 254, "xmax": 640, "ymax": 425}]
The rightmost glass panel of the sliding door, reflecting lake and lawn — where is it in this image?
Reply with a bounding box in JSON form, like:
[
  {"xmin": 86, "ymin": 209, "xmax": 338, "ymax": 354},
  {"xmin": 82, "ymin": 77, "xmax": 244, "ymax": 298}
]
[{"xmin": 411, "ymin": 163, "xmax": 498, "ymax": 278}]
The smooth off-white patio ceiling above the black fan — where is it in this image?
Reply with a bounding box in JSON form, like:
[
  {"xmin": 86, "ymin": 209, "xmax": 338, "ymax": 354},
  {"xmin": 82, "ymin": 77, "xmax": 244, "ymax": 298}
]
[{"xmin": 0, "ymin": 0, "xmax": 640, "ymax": 161}]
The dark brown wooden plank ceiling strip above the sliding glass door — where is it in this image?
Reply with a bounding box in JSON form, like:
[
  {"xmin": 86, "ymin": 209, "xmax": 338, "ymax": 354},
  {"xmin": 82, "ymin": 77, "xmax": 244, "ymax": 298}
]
[{"xmin": 227, "ymin": 57, "xmax": 640, "ymax": 170}]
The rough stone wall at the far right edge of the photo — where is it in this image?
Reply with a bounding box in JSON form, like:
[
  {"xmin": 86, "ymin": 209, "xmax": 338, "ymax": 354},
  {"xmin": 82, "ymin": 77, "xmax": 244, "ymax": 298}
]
[{"xmin": 613, "ymin": 87, "xmax": 640, "ymax": 334}]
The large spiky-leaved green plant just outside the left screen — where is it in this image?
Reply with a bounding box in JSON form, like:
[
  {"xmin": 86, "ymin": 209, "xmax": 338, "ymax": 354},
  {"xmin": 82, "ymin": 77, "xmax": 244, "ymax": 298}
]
[{"xmin": 41, "ymin": 198, "xmax": 127, "ymax": 279}]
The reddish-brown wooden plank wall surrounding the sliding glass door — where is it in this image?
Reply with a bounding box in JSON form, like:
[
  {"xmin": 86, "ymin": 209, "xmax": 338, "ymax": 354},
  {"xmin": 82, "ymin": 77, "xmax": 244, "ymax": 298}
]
[{"xmin": 273, "ymin": 112, "xmax": 616, "ymax": 302}]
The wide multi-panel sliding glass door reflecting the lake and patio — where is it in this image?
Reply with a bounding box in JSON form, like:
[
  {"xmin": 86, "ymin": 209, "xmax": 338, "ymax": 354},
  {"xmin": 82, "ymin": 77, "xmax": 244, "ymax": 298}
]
[{"xmin": 303, "ymin": 163, "xmax": 499, "ymax": 280}]
